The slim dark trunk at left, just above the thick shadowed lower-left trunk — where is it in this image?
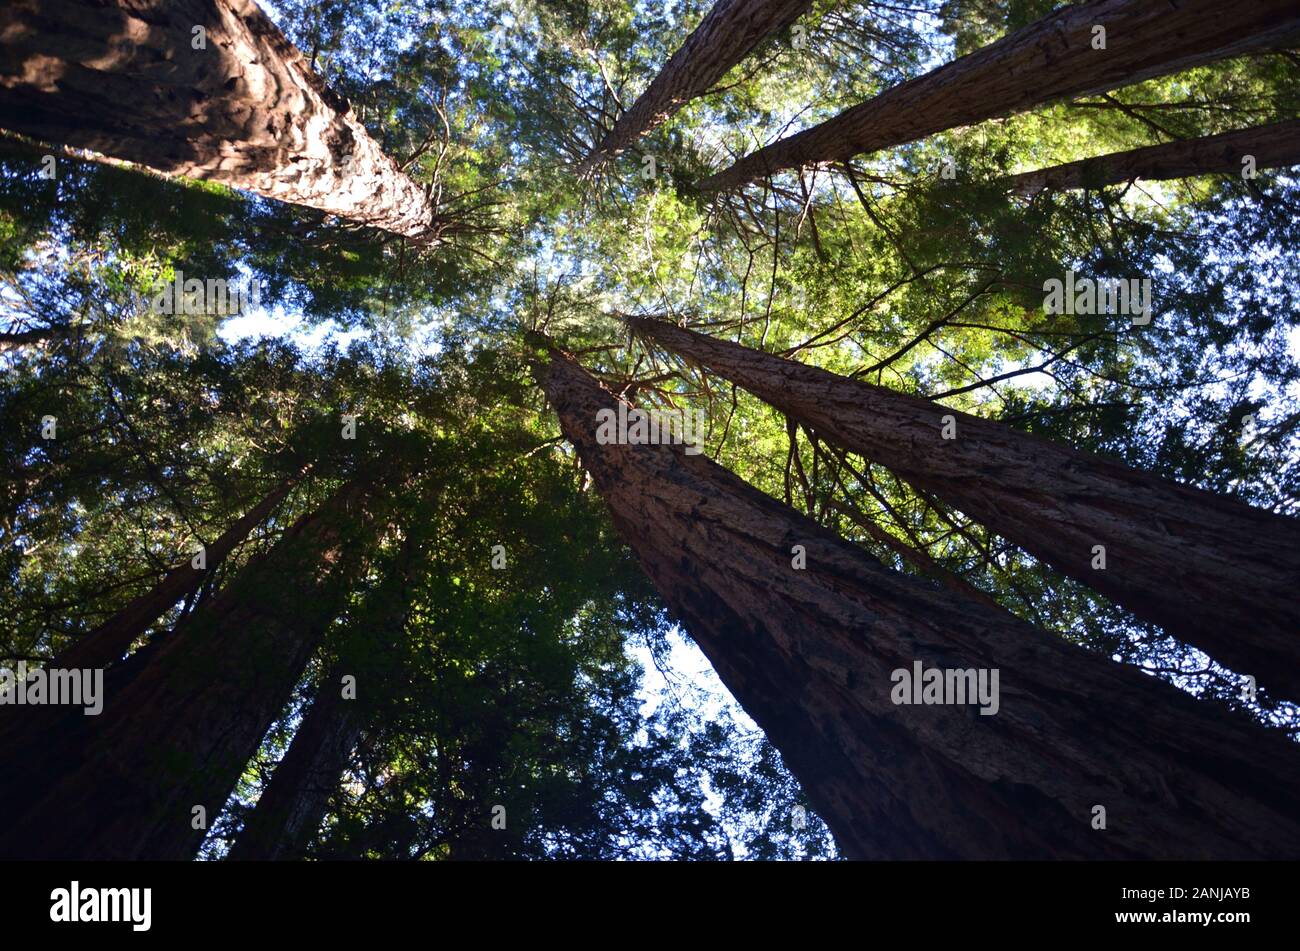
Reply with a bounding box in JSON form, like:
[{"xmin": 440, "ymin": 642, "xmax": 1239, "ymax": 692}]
[{"xmin": 47, "ymin": 476, "xmax": 300, "ymax": 669}]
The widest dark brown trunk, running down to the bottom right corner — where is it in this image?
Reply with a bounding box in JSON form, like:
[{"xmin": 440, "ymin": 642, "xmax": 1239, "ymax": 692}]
[{"xmin": 540, "ymin": 353, "xmax": 1300, "ymax": 859}]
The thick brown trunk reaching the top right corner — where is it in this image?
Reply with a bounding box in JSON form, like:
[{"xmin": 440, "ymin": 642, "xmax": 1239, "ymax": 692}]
[{"xmin": 699, "ymin": 0, "xmax": 1300, "ymax": 192}]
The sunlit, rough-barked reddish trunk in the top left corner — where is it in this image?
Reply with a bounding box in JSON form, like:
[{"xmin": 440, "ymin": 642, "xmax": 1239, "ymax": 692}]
[{"xmin": 0, "ymin": 0, "xmax": 438, "ymax": 242}]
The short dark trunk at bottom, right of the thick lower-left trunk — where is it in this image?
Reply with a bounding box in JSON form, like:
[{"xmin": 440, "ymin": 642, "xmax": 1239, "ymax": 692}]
[{"xmin": 228, "ymin": 677, "xmax": 361, "ymax": 861}]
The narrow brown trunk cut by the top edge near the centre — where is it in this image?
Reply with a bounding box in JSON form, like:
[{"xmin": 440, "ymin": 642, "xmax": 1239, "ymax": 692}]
[{"xmin": 582, "ymin": 0, "xmax": 813, "ymax": 171}]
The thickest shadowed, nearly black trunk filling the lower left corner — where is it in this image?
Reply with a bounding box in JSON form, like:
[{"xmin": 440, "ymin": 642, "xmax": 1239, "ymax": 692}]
[{"xmin": 0, "ymin": 481, "xmax": 387, "ymax": 859}]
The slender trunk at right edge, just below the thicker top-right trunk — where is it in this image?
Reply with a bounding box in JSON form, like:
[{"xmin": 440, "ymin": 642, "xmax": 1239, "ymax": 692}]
[{"xmin": 1009, "ymin": 120, "xmax": 1300, "ymax": 196}]
